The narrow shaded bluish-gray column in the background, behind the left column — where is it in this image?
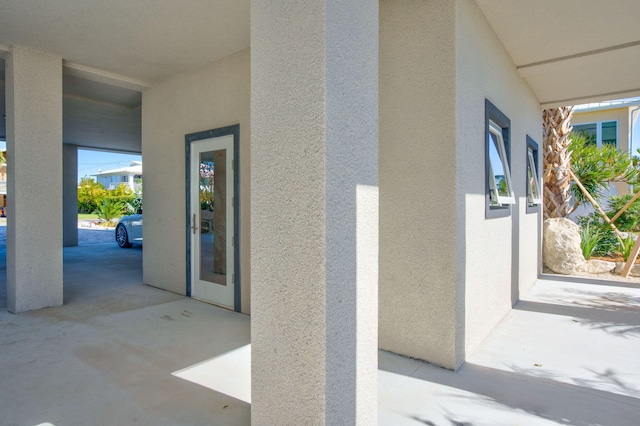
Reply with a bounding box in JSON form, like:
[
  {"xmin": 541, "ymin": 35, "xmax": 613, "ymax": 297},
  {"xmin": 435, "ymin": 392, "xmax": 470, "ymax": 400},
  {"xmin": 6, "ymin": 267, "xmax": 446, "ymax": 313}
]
[{"xmin": 62, "ymin": 144, "xmax": 78, "ymax": 247}]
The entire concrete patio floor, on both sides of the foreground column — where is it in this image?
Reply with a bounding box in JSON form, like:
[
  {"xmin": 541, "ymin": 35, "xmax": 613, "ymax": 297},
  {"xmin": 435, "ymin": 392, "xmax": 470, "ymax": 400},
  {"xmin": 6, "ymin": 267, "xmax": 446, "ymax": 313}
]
[{"xmin": 0, "ymin": 238, "xmax": 640, "ymax": 426}]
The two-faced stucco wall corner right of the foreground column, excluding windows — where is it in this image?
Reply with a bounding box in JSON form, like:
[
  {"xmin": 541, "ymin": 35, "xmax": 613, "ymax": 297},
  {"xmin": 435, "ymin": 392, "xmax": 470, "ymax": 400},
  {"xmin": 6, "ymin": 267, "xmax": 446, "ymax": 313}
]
[{"xmin": 379, "ymin": 0, "xmax": 542, "ymax": 368}]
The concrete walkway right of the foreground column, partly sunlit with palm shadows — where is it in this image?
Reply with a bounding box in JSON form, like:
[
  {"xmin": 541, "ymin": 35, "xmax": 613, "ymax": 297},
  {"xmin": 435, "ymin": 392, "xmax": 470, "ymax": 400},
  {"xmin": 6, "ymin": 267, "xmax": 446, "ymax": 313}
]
[{"xmin": 379, "ymin": 281, "xmax": 640, "ymax": 426}]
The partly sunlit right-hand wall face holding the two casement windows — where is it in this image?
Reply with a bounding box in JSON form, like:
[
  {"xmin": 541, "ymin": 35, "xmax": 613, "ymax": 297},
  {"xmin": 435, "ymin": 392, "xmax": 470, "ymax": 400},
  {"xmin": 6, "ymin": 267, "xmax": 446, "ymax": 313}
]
[{"xmin": 455, "ymin": 0, "xmax": 542, "ymax": 355}]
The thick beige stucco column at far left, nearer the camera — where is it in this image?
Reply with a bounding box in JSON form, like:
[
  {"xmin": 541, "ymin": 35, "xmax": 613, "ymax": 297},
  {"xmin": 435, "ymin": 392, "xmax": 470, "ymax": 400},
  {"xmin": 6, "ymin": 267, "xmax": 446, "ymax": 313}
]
[{"xmin": 6, "ymin": 47, "xmax": 62, "ymax": 313}]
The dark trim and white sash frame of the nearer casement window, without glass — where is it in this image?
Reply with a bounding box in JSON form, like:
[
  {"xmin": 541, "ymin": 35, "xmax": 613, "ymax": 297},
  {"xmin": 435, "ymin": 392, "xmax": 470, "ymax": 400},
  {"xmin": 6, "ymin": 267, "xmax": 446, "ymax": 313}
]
[{"xmin": 484, "ymin": 99, "xmax": 516, "ymax": 219}]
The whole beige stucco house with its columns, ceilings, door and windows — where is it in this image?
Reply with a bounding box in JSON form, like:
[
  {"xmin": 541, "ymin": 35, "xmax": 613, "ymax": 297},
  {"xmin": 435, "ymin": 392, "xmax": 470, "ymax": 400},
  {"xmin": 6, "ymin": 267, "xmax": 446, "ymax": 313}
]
[{"xmin": 0, "ymin": 0, "xmax": 640, "ymax": 425}]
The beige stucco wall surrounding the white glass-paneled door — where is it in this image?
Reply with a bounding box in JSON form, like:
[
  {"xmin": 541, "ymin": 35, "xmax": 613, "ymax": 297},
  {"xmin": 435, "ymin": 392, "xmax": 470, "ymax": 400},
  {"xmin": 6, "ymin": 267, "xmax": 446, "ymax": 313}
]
[{"xmin": 142, "ymin": 49, "xmax": 251, "ymax": 313}]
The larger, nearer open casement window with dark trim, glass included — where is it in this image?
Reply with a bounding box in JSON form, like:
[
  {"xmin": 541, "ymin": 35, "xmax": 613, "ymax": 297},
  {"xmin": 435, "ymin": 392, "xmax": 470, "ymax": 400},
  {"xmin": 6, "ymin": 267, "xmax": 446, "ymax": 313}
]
[{"xmin": 485, "ymin": 100, "xmax": 516, "ymax": 219}]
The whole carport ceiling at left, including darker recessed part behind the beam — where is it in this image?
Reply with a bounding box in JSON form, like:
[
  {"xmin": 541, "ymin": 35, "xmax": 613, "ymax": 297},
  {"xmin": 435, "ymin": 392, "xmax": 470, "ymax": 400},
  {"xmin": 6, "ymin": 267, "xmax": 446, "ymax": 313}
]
[{"xmin": 0, "ymin": 0, "xmax": 249, "ymax": 152}]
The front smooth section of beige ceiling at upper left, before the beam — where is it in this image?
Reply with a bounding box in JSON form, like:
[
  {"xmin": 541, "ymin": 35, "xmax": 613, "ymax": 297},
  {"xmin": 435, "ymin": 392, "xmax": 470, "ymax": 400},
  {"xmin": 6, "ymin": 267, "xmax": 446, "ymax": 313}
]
[{"xmin": 0, "ymin": 0, "xmax": 249, "ymax": 85}]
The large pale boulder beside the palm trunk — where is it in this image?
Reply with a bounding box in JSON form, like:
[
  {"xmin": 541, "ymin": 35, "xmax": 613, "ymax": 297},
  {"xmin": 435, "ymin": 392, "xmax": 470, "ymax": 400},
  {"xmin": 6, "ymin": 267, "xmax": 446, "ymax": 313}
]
[{"xmin": 542, "ymin": 218, "xmax": 584, "ymax": 275}]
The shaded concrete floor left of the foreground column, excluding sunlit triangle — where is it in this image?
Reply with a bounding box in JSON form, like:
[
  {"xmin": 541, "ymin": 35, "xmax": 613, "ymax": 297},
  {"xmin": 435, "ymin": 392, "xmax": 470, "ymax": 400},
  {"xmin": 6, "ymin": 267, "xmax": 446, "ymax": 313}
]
[{"xmin": 0, "ymin": 241, "xmax": 250, "ymax": 426}]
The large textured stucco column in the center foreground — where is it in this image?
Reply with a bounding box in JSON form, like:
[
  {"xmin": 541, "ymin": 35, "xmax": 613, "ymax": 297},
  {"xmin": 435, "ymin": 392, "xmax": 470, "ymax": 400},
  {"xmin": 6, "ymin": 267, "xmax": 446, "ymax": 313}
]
[{"xmin": 251, "ymin": 0, "xmax": 378, "ymax": 425}]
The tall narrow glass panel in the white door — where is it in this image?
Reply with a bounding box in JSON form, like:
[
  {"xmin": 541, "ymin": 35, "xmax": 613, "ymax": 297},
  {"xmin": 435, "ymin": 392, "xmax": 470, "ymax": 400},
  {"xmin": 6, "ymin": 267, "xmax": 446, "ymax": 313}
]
[{"xmin": 199, "ymin": 149, "xmax": 227, "ymax": 286}]
